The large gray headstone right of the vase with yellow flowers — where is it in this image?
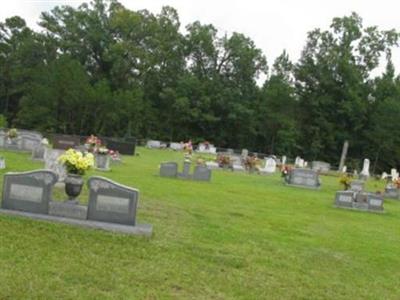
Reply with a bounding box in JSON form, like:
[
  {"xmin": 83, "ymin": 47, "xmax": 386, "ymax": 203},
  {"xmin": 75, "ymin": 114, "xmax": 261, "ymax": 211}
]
[{"xmin": 88, "ymin": 176, "xmax": 139, "ymax": 225}]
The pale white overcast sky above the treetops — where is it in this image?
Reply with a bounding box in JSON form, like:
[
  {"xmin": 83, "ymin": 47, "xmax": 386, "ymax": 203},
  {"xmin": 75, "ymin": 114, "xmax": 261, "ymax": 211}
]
[{"xmin": 0, "ymin": 0, "xmax": 400, "ymax": 73}]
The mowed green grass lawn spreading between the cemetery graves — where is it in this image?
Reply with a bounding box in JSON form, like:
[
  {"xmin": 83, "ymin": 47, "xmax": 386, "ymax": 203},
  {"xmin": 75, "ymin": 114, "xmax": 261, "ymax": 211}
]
[{"xmin": 0, "ymin": 148, "xmax": 400, "ymax": 299}]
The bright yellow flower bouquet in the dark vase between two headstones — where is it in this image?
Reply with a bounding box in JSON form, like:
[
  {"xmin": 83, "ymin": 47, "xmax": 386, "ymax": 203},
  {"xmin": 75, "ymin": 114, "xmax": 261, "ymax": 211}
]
[{"xmin": 58, "ymin": 149, "xmax": 94, "ymax": 175}]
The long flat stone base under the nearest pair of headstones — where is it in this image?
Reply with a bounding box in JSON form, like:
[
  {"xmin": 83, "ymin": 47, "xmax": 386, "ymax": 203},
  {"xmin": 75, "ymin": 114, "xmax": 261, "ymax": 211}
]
[{"xmin": 0, "ymin": 209, "xmax": 153, "ymax": 237}]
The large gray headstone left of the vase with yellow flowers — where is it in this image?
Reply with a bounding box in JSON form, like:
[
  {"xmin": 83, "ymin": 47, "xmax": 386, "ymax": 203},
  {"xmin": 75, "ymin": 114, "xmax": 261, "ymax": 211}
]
[{"xmin": 1, "ymin": 170, "xmax": 57, "ymax": 214}]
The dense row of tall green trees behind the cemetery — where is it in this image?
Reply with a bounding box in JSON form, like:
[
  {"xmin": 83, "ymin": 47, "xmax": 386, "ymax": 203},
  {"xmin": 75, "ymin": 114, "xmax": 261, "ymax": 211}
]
[{"xmin": 0, "ymin": 0, "xmax": 400, "ymax": 170}]
